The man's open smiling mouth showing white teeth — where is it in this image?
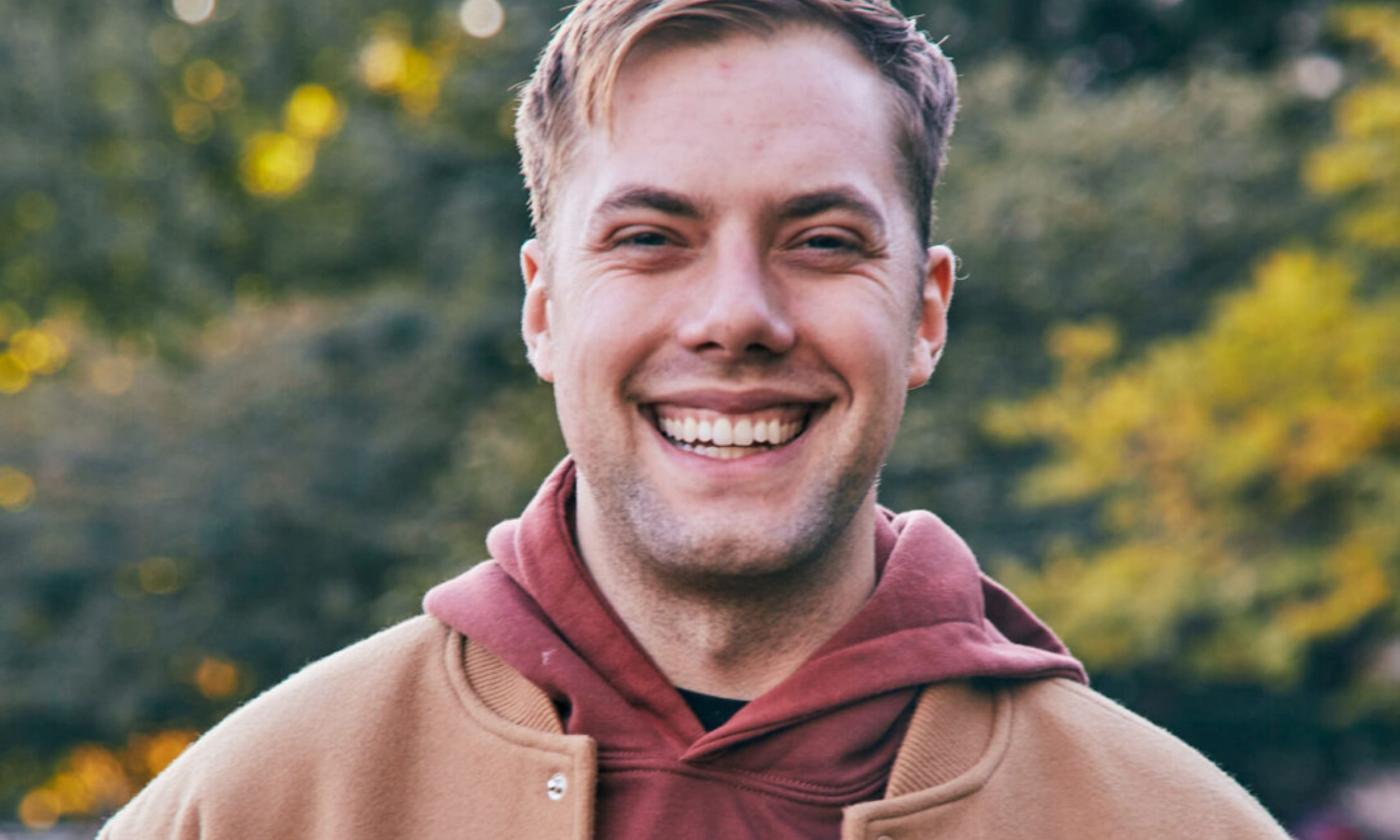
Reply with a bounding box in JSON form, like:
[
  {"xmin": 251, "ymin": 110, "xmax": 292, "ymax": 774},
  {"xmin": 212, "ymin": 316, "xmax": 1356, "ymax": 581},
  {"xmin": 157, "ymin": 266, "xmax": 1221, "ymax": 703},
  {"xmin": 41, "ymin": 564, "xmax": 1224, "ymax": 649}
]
[{"xmin": 643, "ymin": 403, "xmax": 819, "ymax": 461}]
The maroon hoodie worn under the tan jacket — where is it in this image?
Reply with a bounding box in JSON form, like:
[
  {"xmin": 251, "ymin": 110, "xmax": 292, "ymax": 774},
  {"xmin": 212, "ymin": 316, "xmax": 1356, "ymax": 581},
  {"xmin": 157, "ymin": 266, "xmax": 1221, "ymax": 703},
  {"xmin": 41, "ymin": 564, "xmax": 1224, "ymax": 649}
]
[{"xmin": 424, "ymin": 459, "xmax": 1086, "ymax": 840}]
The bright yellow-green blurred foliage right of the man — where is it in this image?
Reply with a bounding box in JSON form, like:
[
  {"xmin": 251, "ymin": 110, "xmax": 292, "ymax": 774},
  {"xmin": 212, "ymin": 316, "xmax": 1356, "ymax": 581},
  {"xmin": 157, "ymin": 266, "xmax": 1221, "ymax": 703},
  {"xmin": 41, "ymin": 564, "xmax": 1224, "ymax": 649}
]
[{"xmin": 990, "ymin": 251, "xmax": 1400, "ymax": 683}]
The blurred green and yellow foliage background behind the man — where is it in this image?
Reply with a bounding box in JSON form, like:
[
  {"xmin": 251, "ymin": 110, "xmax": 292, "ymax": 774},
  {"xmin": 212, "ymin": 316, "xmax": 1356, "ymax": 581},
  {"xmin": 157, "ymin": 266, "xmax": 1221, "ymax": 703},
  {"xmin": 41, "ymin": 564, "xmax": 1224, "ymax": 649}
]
[{"xmin": 0, "ymin": 0, "xmax": 1400, "ymax": 840}]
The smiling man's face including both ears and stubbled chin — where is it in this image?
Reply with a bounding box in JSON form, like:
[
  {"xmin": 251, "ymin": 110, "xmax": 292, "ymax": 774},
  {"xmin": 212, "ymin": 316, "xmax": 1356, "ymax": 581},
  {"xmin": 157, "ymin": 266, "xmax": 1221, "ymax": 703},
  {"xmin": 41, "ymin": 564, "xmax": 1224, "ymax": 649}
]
[{"xmin": 522, "ymin": 28, "xmax": 952, "ymax": 577}]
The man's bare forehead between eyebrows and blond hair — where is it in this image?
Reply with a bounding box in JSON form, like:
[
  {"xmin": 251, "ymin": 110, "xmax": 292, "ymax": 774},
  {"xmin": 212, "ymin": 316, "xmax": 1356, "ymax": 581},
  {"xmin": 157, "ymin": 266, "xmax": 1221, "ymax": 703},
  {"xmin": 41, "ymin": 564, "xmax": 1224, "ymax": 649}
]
[{"xmin": 560, "ymin": 27, "xmax": 913, "ymax": 235}]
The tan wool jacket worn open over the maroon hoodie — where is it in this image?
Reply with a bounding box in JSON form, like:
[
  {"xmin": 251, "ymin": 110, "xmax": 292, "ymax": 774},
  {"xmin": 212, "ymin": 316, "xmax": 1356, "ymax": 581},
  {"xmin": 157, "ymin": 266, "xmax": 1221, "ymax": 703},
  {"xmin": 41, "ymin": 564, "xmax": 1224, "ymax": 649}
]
[{"xmin": 99, "ymin": 617, "xmax": 1287, "ymax": 840}]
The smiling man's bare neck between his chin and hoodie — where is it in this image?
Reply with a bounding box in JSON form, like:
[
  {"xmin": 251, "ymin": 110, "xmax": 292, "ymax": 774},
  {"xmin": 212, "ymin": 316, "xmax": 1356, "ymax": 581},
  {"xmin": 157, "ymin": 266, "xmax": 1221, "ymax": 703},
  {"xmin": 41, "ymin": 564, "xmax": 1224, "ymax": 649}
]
[{"xmin": 575, "ymin": 493, "xmax": 875, "ymax": 700}]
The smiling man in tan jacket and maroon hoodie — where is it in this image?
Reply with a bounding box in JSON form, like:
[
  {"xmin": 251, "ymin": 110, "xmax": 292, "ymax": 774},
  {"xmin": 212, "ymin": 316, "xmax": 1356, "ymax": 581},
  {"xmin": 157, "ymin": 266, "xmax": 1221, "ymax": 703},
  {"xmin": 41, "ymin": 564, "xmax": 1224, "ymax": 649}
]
[{"xmin": 104, "ymin": 0, "xmax": 1284, "ymax": 839}]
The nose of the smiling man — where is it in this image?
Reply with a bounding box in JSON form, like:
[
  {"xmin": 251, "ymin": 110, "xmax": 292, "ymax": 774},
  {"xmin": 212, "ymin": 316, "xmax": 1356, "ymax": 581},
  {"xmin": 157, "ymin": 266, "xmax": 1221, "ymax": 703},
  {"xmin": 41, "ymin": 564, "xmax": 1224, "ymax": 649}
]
[{"xmin": 678, "ymin": 248, "xmax": 797, "ymax": 361}]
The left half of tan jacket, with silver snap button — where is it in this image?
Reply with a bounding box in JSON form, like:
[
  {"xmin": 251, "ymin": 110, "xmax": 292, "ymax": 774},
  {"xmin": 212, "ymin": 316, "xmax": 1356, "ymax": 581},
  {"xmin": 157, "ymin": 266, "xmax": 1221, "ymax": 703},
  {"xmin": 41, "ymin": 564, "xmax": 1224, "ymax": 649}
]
[{"xmin": 99, "ymin": 616, "xmax": 595, "ymax": 840}]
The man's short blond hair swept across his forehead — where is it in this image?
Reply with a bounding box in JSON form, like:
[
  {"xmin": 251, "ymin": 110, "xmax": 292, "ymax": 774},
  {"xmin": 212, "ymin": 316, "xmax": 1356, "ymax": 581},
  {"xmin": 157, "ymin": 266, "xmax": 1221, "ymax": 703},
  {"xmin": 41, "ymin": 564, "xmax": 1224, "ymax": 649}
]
[{"xmin": 515, "ymin": 0, "xmax": 958, "ymax": 244}]
